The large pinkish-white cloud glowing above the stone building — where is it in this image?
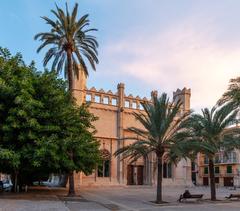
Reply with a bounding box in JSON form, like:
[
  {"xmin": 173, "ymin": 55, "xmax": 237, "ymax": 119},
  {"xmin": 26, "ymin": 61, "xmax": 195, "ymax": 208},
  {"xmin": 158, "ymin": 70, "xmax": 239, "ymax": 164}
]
[{"xmin": 101, "ymin": 18, "xmax": 240, "ymax": 110}]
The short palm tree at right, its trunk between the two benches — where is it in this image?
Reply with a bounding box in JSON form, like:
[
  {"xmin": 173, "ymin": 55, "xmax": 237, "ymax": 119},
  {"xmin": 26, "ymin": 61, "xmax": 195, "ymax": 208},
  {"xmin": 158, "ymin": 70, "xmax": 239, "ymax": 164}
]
[{"xmin": 187, "ymin": 104, "xmax": 240, "ymax": 200}]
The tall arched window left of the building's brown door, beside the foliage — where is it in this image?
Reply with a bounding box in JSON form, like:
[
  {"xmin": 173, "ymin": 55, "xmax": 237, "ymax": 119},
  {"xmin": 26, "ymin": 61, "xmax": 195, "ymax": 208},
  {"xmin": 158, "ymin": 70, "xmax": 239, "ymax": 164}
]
[{"xmin": 97, "ymin": 149, "xmax": 111, "ymax": 177}]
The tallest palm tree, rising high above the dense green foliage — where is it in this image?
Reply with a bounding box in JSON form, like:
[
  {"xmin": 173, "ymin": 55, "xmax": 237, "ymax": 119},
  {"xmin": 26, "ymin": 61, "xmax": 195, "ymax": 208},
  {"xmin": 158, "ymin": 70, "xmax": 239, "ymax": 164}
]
[{"xmin": 34, "ymin": 3, "xmax": 98, "ymax": 195}]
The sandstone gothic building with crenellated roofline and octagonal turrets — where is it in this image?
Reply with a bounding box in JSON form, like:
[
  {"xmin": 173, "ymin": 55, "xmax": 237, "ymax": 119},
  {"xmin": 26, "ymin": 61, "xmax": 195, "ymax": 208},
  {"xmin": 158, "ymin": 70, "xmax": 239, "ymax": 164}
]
[{"xmin": 73, "ymin": 73, "xmax": 192, "ymax": 187}]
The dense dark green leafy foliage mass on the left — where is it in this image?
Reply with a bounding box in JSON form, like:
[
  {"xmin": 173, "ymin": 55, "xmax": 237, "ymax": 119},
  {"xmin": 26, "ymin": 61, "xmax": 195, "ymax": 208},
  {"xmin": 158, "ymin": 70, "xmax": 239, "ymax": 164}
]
[{"xmin": 0, "ymin": 48, "xmax": 99, "ymax": 186}]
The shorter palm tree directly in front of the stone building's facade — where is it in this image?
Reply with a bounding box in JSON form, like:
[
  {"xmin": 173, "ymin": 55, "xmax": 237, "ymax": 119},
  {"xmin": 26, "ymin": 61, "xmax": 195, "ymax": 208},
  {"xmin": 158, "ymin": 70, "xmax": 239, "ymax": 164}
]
[{"xmin": 115, "ymin": 93, "xmax": 190, "ymax": 203}]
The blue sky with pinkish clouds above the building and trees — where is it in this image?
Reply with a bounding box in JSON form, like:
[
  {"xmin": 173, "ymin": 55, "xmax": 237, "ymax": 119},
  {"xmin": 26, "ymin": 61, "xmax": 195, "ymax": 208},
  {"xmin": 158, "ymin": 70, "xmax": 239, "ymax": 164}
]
[{"xmin": 0, "ymin": 0, "xmax": 240, "ymax": 111}]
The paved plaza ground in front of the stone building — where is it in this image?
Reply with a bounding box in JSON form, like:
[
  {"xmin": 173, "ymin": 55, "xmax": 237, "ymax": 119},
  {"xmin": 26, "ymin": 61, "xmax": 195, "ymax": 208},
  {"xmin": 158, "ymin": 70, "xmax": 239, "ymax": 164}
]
[{"xmin": 0, "ymin": 186, "xmax": 240, "ymax": 211}]
